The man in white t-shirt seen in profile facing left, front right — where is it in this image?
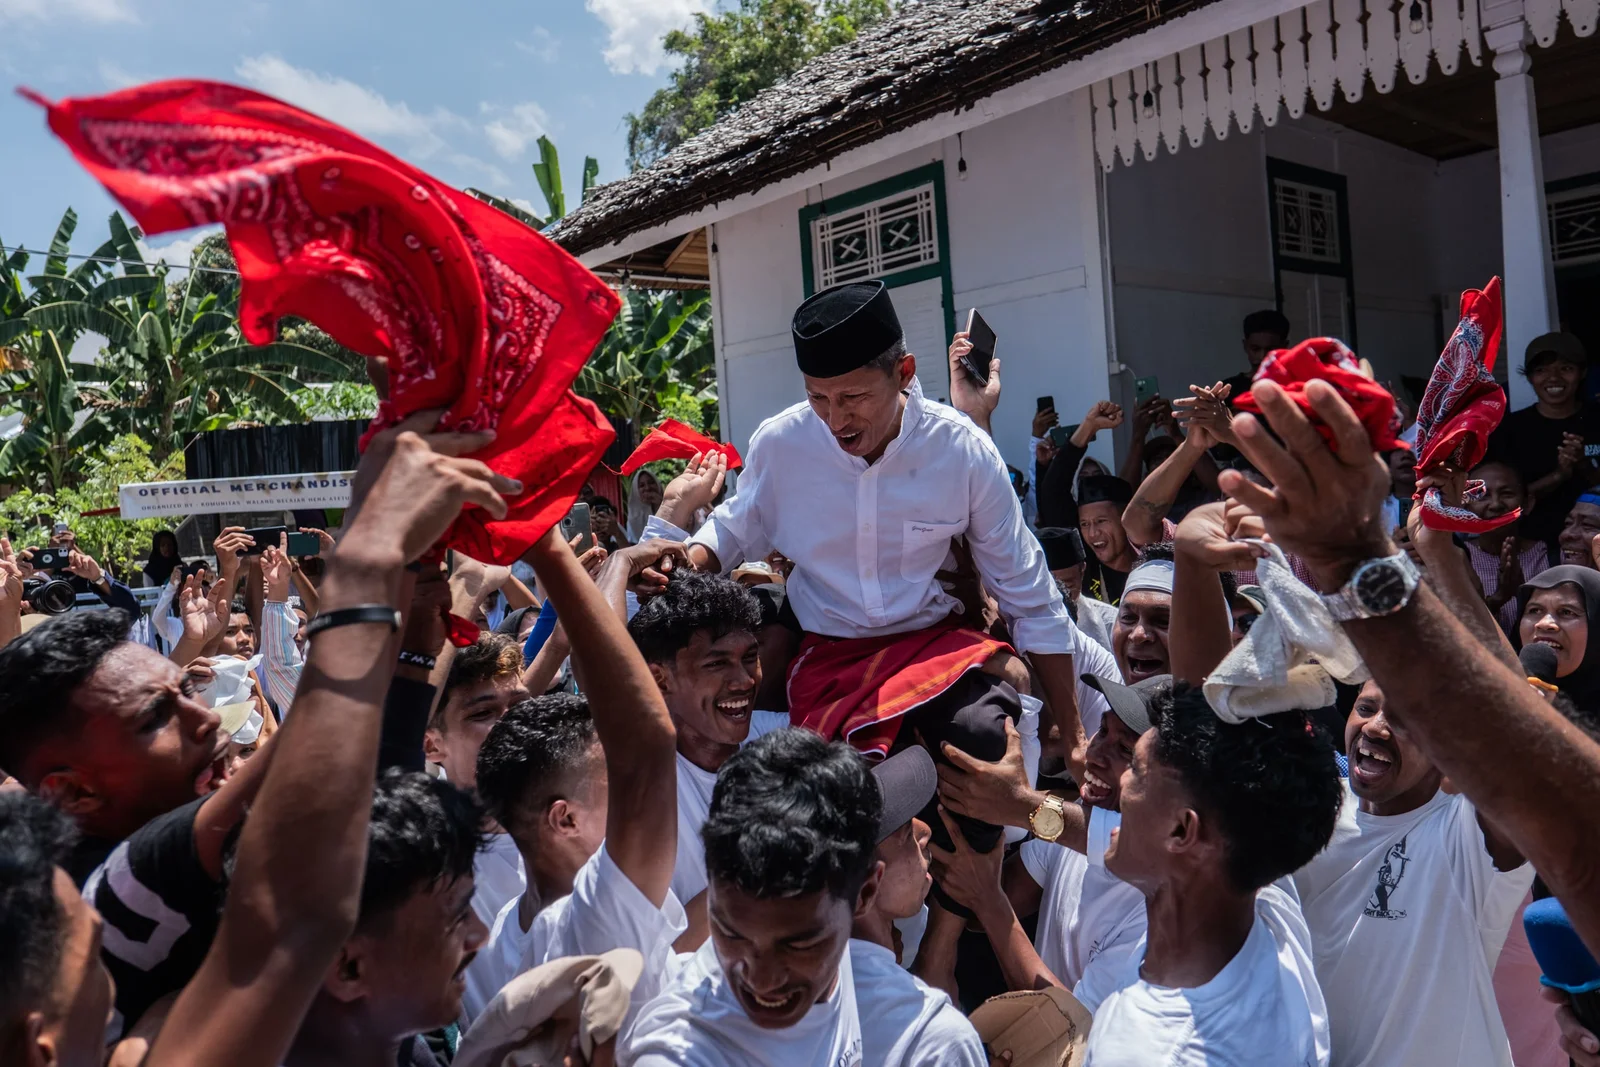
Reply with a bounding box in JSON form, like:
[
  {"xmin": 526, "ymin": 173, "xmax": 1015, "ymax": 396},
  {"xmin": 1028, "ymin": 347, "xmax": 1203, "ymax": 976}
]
[{"xmin": 1074, "ymin": 685, "xmax": 1341, "ymax": 1067}]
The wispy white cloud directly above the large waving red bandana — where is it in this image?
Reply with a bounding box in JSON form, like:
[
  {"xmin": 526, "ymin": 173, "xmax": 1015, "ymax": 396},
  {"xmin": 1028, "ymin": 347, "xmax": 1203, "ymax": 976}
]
[{"xmin": 233, "ymin": 54, "xmax": 467, "ymax": 158}]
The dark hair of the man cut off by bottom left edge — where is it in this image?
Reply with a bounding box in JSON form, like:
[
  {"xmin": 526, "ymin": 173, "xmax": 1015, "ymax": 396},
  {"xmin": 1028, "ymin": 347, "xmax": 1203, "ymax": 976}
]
[{"xmin": 0, "ymin": 790, "xmax": 77, "ymax": 1027}]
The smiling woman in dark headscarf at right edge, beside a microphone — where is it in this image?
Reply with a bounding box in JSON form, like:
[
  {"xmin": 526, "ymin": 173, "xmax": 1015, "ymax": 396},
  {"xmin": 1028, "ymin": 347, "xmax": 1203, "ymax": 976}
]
[{"xmin": 1517, "ymin": 565, "xmax": 1600, "ymax": 713}]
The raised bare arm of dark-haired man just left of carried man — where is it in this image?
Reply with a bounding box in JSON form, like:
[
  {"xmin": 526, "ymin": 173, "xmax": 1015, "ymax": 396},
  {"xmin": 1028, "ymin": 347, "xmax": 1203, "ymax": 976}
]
[{"xmin": 525, "ymin": 531, "xmax": 683, "ymax": 907}]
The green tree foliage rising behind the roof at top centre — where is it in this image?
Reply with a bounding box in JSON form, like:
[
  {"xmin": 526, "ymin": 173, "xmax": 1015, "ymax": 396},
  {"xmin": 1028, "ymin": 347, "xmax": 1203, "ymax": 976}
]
[{"xmin": 627, "ymin": 0, "xmax": 891, "ymax": 170}]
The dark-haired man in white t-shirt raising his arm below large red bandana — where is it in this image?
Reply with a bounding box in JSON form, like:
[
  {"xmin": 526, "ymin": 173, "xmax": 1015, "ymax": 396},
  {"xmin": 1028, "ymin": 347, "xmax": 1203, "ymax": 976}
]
[{"xmin": 464, "ymin": 541, "xmax": 685, "ymax": 1021}]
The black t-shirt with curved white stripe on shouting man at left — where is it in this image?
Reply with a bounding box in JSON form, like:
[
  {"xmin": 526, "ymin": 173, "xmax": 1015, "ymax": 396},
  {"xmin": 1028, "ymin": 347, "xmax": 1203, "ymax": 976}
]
[{"xmin": 85, "ymin": 797, "xmax": 224, "ymax": 1035}]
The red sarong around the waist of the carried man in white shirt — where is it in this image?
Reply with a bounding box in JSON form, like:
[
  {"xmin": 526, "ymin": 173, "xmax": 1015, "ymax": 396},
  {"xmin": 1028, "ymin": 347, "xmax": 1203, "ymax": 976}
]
[{"xmin": 789, "ymin": 624, "xmax": 1011, "ymax": 757}]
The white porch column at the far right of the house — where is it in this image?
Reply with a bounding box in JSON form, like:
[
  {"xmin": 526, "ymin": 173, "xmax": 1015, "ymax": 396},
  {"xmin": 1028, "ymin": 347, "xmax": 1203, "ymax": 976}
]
[{"xmin": 1483, "ymin": 12, "xmax": 1557, "ymax": 410}]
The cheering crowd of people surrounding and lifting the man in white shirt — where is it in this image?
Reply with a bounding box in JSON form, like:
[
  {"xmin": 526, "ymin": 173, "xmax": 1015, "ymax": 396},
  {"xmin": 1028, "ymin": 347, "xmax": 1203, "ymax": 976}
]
[{"xmin": 0, "ymin": 283, "xmax": 1600, "ymax": 1067}]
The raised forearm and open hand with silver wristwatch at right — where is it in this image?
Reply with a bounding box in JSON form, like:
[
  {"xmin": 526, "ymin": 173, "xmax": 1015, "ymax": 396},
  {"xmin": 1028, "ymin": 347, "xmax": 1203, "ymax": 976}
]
[{"xmin": 1222, "ymin": 382, "xmax": 1600, "ymax": 950}]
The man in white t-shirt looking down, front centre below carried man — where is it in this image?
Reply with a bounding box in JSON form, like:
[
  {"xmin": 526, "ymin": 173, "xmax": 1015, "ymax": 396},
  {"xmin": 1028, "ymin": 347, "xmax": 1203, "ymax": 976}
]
[{"xmin": 618, "ymin": 729, "xmax": 883, "ymax": 1067}]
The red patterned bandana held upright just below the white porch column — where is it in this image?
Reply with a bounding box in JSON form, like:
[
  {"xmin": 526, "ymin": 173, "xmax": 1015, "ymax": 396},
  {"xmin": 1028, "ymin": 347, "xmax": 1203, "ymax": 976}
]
[{"xmin": 1416, "ymin": 277, "xmax": 1522, "ymax": 533}]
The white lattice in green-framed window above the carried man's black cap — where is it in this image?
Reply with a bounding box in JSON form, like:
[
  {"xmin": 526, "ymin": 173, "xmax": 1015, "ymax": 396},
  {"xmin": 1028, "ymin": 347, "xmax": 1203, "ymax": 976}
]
[{"xmin": 811, "ymin": 182, "xmax": 939, "ymax": 290}]
